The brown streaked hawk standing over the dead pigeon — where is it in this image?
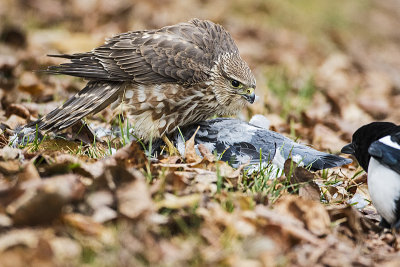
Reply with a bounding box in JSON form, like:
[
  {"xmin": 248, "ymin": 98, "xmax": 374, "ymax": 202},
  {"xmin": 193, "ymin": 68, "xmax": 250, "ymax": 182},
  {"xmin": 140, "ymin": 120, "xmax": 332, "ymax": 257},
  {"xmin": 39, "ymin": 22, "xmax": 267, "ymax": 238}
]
[{"xmin": 30, "ymin": 19, "xmax": 256, "ymax": 141}]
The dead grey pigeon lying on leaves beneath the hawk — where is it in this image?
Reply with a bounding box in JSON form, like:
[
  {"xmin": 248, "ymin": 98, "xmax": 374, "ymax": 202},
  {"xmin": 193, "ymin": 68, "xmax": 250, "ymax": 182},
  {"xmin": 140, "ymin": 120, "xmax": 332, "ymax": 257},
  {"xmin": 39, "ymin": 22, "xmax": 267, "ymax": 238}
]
[{"xmin": 155, "ymin": 118, "xmax": 351, "ymax": 171}]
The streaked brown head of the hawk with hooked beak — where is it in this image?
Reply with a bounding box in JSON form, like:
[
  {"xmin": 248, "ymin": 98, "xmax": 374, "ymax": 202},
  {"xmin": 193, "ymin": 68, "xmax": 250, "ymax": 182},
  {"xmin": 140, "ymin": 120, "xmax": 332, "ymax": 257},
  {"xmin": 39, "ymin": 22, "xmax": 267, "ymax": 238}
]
[{"xmin": 212, "ymin": 53, "xmax": 256, "ymax": 109}]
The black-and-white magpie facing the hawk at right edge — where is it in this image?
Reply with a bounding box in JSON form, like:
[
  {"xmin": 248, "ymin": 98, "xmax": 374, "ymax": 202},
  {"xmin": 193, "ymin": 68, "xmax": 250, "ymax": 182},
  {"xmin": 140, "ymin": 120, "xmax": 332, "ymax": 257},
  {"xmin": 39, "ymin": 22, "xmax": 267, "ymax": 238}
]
[{"xmin": 342, "ymin": 122, "xmax": 400, "ymax": 229}]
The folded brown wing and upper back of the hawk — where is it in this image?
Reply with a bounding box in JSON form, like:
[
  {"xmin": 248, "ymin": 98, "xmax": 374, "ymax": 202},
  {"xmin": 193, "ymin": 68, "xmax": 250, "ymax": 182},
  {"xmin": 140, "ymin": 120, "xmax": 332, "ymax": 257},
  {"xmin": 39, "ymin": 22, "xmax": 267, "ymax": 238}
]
[{"xmin": 47, "ymin": 19, "xmax": 238, "ymax": 84}]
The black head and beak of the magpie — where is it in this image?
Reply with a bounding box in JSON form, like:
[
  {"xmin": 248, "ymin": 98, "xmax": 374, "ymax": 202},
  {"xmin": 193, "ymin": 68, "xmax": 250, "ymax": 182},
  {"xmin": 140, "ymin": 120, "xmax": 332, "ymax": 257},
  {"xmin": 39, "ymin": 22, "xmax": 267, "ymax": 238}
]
[{"xmin": 341, "ymin": 122, "xmax": 400, "ymax": 172}]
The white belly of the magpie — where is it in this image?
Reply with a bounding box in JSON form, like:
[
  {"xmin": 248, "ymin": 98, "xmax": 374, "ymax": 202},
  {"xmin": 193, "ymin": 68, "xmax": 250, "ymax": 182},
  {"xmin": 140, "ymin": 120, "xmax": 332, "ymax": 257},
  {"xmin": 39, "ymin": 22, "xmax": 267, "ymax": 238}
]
[{"xmin": 368, "ymin": 157, "xmax": 400, "ymax": 223}]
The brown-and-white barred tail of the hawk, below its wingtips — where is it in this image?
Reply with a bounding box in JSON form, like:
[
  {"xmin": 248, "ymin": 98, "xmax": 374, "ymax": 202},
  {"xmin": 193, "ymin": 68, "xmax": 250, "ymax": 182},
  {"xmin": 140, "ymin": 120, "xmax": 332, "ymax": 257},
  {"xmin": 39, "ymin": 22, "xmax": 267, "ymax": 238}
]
[{"xmin": 27, "ymin": 81, "xmax": 125, "ymax": 131}]
